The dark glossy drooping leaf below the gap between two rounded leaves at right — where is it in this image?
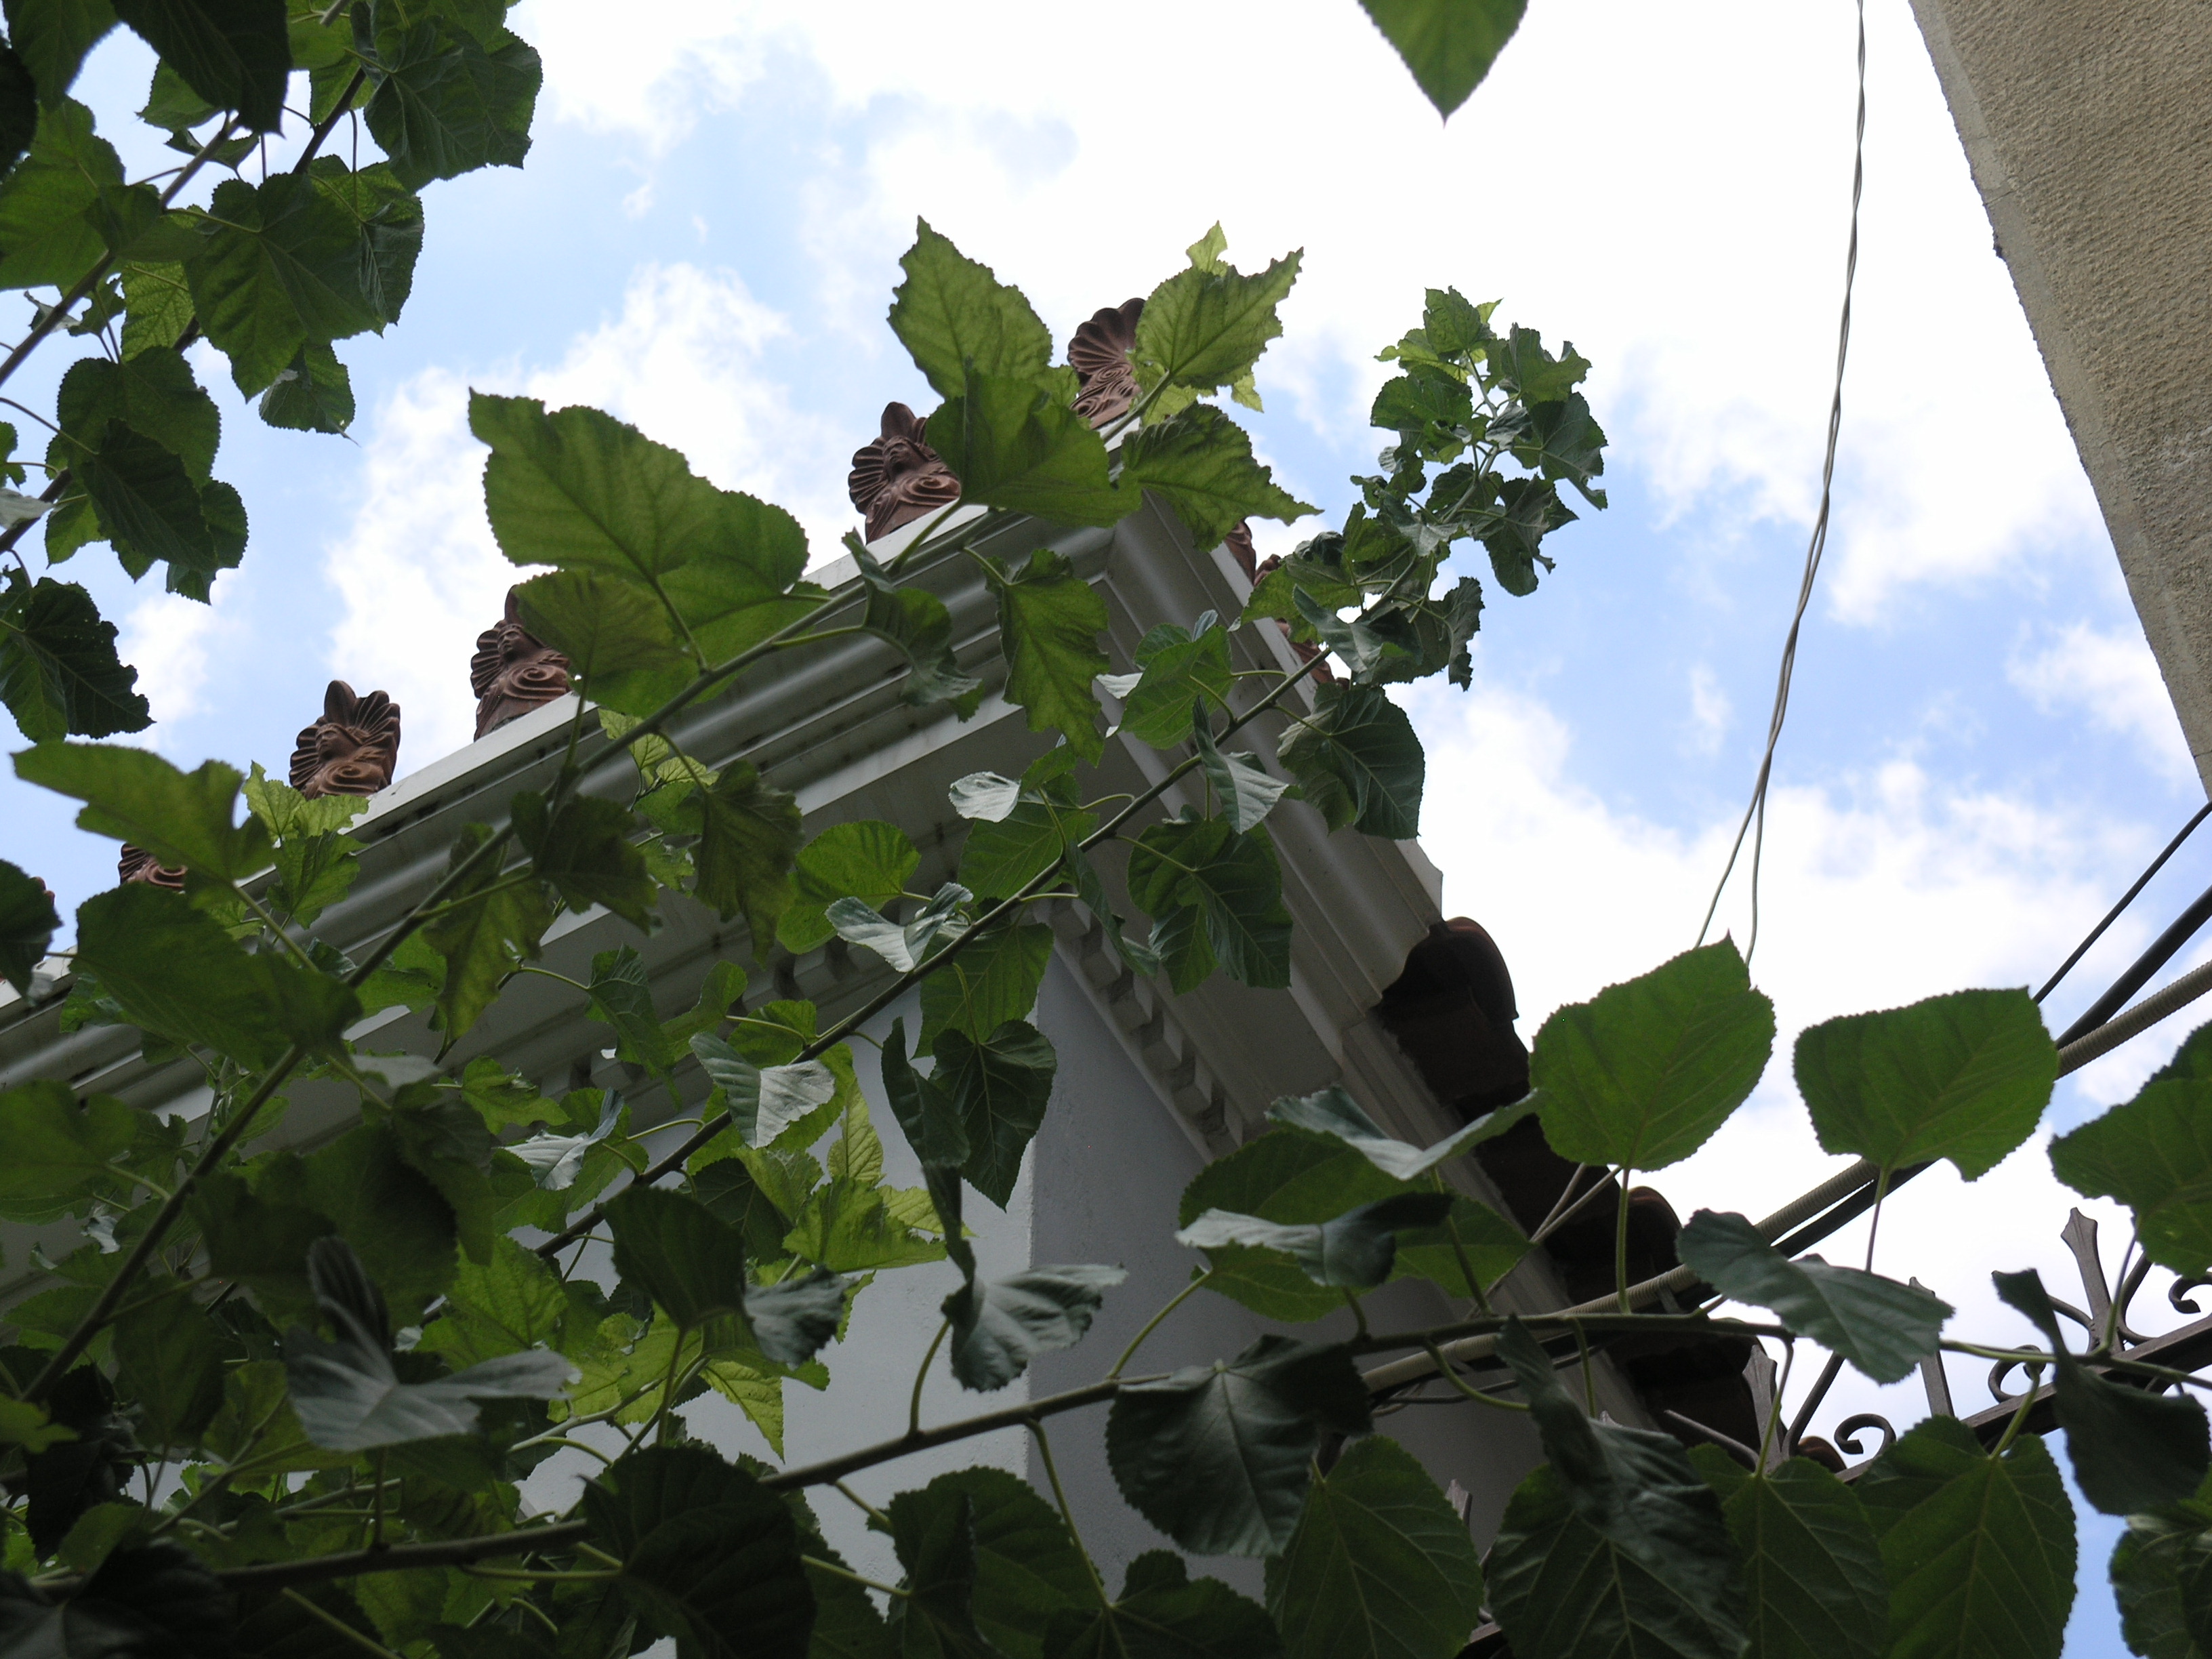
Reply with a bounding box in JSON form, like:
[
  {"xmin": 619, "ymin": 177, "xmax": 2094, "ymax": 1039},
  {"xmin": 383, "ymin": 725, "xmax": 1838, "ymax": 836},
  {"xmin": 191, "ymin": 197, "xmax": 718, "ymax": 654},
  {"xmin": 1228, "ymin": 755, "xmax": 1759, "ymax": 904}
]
[{"xmin": 1675, "ymin": 1210, "xmax": 1951, "ymax": 1382}]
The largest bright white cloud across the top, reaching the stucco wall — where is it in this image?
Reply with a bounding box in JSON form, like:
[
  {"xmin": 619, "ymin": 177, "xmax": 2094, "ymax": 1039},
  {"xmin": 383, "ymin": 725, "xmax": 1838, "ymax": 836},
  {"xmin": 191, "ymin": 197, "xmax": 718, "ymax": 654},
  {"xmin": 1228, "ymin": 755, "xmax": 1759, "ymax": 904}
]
[{"xmin": 513, "ymin": 0, "xmax": 2102, "ymax": 621}]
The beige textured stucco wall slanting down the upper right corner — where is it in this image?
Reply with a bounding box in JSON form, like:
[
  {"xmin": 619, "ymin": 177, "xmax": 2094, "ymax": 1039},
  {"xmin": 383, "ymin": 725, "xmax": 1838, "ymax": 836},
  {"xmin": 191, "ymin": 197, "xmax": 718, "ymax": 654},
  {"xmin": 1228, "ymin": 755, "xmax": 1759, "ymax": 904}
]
[{"xmin": 1913, "ymin": 0, "xmax": 2212, "ymax": 787}]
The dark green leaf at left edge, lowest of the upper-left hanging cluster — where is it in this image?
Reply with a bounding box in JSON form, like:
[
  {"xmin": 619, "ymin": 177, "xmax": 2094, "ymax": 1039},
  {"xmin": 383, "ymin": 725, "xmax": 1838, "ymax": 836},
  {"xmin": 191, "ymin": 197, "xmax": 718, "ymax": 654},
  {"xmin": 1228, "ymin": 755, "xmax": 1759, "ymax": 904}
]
[{"xmin": 0, "ymin": 571, "xmax": 152, "ymax": 743}]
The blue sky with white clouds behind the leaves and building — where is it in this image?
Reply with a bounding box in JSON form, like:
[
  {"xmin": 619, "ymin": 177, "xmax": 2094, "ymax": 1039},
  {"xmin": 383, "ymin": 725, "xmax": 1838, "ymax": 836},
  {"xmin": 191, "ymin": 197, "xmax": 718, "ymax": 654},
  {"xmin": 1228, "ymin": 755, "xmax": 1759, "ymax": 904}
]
[{"xmin": 0, "ymin": 0, "xmax": 2212, "ymax": 1654}]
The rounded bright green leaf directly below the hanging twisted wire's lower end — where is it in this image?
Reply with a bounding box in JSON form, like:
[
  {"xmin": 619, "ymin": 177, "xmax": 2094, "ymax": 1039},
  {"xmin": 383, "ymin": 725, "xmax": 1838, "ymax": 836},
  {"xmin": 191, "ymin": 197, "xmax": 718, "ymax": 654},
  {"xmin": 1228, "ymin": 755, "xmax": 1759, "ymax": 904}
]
[{"xmin": 1528, "ymin": 940, "xmax": 1769, "ymax": 1170}]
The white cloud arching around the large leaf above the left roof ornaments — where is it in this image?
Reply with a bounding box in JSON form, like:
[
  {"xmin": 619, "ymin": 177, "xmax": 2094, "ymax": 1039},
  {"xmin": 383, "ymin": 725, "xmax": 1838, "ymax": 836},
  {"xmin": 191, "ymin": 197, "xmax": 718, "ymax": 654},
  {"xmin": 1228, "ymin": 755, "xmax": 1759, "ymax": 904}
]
[{"xmin": 327, "ymin": 266, "xmax": 852, "ymax": 772}]
